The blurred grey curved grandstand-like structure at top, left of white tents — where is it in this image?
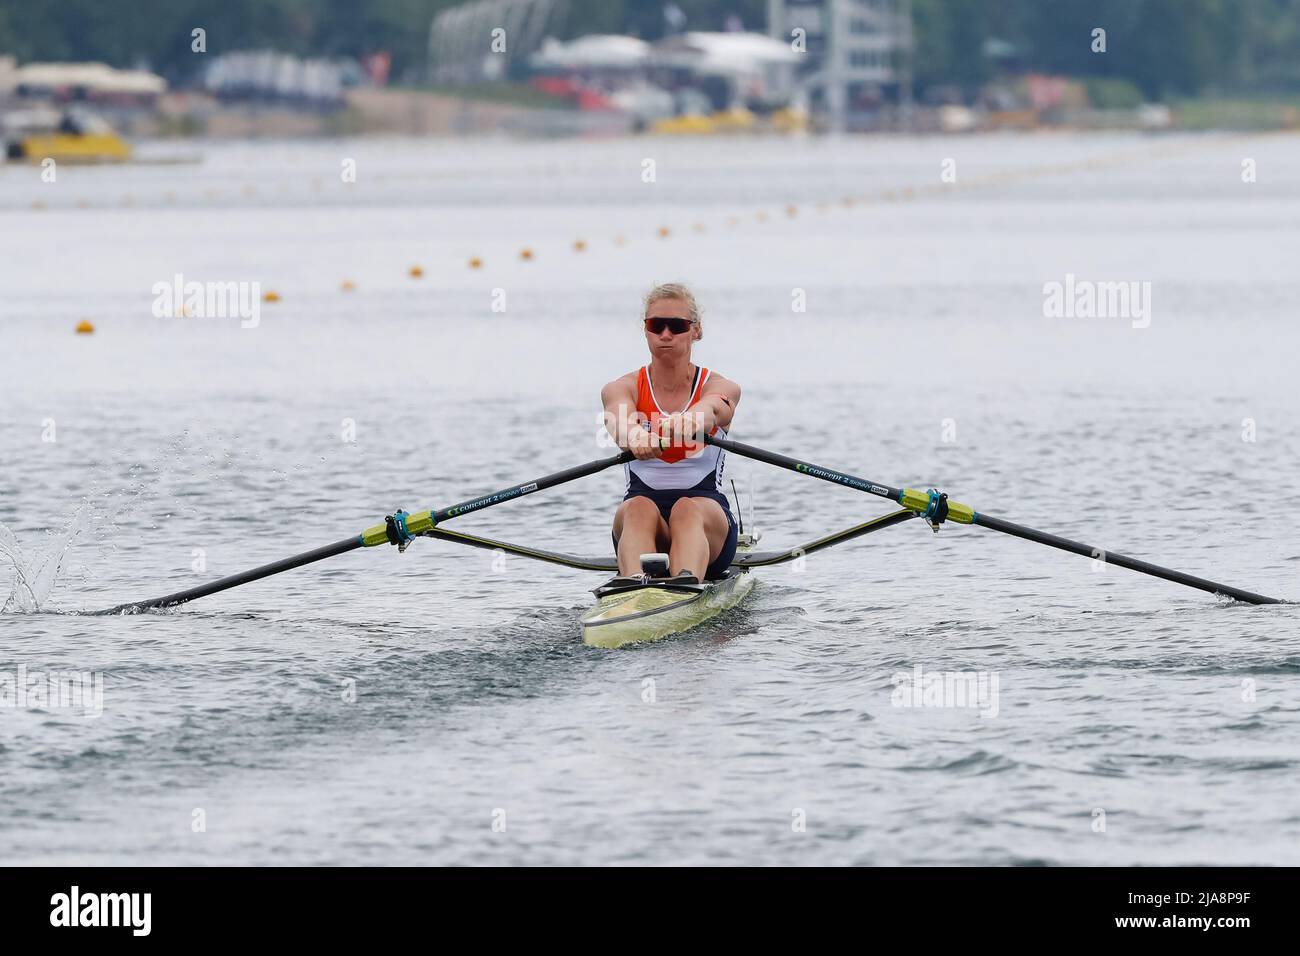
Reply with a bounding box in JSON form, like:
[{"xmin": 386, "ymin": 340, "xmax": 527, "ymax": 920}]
[{"xmin": 429, "ymin": 0, "xmax": 566, "ymax": 86}]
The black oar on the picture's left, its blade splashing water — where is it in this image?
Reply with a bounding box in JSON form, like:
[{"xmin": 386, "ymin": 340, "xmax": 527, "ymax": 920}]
[{"xmin": 96, "ymin": 451, "xmax": 632, "ymax": 614}]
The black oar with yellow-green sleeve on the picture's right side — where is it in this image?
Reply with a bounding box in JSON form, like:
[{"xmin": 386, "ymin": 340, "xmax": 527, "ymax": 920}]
[{"xmin": 705, "ymin": 436, "xmax": 1284, "ymax": 604}]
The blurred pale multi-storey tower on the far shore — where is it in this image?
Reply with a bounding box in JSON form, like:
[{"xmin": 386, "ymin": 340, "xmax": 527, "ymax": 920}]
[{"xmin": 767, "ymin": 0, "xmax": 913, "ymax": 130}]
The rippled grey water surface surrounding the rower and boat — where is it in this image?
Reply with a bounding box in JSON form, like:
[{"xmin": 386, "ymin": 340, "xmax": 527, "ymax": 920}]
[{"xmin": 0, "ymin": 135, "xmax": 1300, "ymax": 864}]
